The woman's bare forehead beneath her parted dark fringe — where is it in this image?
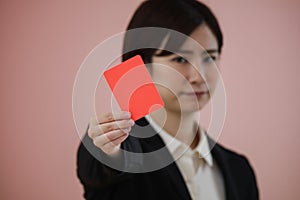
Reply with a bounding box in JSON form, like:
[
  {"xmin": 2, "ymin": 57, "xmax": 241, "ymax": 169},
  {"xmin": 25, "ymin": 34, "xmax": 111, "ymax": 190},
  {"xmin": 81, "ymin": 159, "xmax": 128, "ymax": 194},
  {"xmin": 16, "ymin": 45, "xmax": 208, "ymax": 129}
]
[{"xmin": 180, "ymin": 24, "xmax": 218, "ymax": 51}]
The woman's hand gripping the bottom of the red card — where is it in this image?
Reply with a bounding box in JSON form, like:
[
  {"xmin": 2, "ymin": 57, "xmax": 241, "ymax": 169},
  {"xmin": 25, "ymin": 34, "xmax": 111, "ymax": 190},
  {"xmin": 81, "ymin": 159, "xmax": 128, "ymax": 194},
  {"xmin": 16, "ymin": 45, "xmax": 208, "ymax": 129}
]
[{"xmin": 88, "ymin": 112, "xmax": 134, "ymax": 156}]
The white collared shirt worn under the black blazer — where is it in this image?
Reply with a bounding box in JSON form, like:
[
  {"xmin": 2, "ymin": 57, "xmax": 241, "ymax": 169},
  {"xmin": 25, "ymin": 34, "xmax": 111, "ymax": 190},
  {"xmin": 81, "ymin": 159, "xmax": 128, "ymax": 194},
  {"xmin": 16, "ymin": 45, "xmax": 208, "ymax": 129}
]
[{"xmin": 146, "ymin": 115, "xmax": 225, "ymax": 200}]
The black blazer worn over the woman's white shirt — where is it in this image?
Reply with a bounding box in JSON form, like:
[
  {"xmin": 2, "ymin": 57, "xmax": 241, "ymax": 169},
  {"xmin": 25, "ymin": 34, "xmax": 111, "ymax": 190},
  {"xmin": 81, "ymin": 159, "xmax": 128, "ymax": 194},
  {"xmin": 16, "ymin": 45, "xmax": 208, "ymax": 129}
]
[{"xmin": 77, "ymin": 119, "xmax": 259, "ymax": 200}]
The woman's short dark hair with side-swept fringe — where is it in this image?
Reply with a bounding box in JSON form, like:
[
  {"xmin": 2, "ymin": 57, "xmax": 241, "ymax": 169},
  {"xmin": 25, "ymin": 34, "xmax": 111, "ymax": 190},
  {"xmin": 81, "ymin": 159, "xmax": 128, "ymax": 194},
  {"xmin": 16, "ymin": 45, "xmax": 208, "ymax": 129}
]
[{"xmin": 122, "ymin": 0, "xmax": 223, "ymax": 63}]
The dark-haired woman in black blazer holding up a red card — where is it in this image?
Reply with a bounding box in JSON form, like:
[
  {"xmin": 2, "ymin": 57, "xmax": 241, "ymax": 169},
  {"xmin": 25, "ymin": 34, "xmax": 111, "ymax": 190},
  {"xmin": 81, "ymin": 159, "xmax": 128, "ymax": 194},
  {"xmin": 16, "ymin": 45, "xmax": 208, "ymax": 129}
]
[{"xmin": 77, "ymin": 0, "xmax": 258, "ymax": 200}]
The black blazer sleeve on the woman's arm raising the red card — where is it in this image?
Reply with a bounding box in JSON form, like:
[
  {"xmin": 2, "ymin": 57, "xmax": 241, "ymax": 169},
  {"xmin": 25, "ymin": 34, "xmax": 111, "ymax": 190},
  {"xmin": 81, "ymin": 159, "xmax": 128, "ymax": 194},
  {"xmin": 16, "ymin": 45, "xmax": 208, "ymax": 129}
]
[{"xmin": 77, "ymin": 127, "xmax": 142, "ymax": 200}]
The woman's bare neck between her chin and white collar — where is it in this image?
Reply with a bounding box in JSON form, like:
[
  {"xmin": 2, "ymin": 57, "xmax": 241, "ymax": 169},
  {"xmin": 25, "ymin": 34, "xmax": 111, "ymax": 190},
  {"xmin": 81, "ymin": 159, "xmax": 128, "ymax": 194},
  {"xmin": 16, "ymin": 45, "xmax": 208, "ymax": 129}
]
[{"xmin": 150, "ymin": 109, "xmax": 200, "ymax": 149}]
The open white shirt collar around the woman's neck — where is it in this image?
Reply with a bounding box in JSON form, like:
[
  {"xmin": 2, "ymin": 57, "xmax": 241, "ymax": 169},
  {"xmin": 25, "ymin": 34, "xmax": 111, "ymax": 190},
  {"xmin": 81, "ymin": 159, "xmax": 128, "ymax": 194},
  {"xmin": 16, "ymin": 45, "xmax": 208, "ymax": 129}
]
[{"xmin": 145, "ymin": 115, "xmax": 213, "ymax": 167}]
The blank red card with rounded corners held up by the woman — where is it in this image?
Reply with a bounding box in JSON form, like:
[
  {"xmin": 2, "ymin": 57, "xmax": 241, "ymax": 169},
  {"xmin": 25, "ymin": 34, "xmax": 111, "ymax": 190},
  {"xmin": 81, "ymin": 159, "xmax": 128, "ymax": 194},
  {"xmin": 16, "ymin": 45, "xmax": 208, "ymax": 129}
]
[{"xmin": 104, "ymin": 55, "xmax": 164, "ymax": 120}]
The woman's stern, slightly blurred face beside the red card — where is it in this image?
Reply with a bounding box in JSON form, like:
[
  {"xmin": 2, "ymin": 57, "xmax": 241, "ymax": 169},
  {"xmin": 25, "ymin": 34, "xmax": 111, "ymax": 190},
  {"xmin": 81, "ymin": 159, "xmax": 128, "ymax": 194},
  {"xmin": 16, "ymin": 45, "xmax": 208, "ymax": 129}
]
[{"xmin": 151, "ymin": 24, "xmax": 220, "ymax": 113}]
